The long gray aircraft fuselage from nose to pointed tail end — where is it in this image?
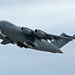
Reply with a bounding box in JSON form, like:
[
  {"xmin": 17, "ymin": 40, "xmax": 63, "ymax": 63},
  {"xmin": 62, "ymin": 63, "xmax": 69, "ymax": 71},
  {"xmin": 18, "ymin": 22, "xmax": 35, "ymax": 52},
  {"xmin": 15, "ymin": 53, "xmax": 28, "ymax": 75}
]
[{"xmin": 0, "ymin": 21, "xmax": 62, "ymax": 53}]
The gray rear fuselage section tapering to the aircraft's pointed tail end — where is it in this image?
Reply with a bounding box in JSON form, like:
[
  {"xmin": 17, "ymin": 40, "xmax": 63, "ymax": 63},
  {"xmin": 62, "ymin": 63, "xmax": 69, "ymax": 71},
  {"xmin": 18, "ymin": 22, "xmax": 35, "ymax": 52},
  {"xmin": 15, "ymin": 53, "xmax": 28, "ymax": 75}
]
[{"xmin": 33, "ymin": 40, "xmax": 61, "ymax": 53}]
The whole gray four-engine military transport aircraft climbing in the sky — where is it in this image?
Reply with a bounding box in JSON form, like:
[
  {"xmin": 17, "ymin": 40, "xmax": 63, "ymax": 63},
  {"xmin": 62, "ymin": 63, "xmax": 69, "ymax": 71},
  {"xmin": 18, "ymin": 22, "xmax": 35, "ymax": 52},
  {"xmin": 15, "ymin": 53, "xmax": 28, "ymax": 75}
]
[{"xmin": 0, "ymin": 21, "xmax": 75, "ymax": 53}]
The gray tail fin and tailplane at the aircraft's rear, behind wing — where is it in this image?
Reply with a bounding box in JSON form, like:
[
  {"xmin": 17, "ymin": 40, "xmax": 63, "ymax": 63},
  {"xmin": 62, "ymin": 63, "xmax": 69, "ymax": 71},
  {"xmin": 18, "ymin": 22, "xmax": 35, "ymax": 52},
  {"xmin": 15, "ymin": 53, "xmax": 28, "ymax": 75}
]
[{"xmin": 51, "ymin": 33, "xmax": 75, "ymax": 48}]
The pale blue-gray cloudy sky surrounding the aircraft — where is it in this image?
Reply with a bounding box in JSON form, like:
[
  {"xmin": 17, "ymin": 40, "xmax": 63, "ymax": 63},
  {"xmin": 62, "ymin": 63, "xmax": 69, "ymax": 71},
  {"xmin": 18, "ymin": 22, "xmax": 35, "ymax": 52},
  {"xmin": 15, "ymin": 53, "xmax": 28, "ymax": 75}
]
[{"xmin": 0, "ymin": 0, "xmax": 75, "ymax": 75}]
